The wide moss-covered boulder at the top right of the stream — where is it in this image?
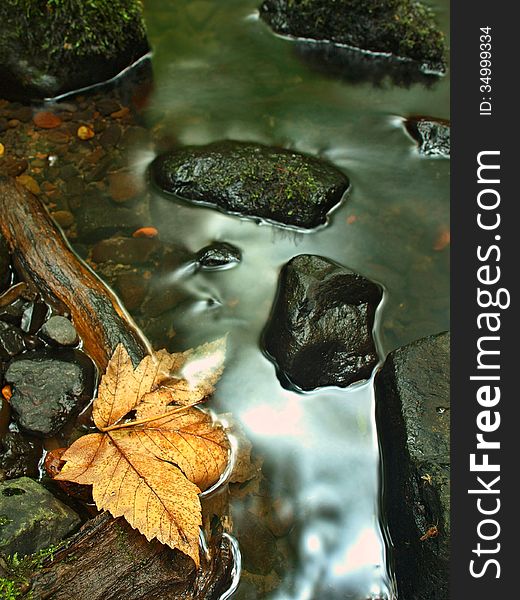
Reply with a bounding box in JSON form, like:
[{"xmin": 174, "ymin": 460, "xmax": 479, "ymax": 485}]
[{"xmin": 260, "ymin": 0, "xmax": 444, "ymax": 70}]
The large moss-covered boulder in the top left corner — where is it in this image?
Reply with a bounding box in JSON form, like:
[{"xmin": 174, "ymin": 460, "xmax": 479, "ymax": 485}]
[{"xmin": 0, "ymin": 0, "xmax": 149, "ymax": 100}]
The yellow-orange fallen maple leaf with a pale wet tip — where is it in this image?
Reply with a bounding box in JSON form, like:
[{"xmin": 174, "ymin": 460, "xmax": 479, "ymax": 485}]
[{"xmin": 55, "ymin": 338, "xmax": 229, "ymax": 566}]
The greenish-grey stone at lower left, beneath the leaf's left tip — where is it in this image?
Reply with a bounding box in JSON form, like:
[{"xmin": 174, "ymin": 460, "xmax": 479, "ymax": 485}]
[{"xmin": 0, "ymin": 477, "xmax": 80, "ymax": 556}]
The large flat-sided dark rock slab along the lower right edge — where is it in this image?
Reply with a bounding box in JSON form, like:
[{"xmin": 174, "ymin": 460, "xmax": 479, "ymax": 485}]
[{"xmin": 376, "ymin": 333, "xmax": 450, "ymax": 600}]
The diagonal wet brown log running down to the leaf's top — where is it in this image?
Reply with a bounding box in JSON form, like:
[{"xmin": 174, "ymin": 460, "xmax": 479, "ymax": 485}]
[{"xmin": 0, "ymin": 177, "xmax": 150, "ymax": 371}]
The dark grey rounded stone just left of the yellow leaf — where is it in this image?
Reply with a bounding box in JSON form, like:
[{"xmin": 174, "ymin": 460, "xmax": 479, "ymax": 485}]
[{"xmin": 5, "ymin": 349, "xmax": 95, "ymax": 436}]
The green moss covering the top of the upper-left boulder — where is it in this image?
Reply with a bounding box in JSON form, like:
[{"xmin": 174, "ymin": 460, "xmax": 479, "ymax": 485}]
[{"xmin": 0, "ymin": 0, "xmax": 145, "ymax": 61}]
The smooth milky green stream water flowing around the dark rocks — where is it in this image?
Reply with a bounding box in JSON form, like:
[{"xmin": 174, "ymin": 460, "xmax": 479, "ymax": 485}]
[{"xmin": 80, "ymin": 0, "xmax": 449, "ymax": 600}]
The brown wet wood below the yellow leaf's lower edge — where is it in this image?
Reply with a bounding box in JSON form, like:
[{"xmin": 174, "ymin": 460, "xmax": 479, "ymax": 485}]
[{"xmin": 31, "ymin": 513, "xmax": 233, "ymax": 600}]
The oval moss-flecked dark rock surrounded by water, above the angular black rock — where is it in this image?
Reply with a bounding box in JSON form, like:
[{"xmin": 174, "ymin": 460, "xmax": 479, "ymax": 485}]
[{"xmin": 151, "ymin": 141, "xmax": 349, "ymax": 229}]
